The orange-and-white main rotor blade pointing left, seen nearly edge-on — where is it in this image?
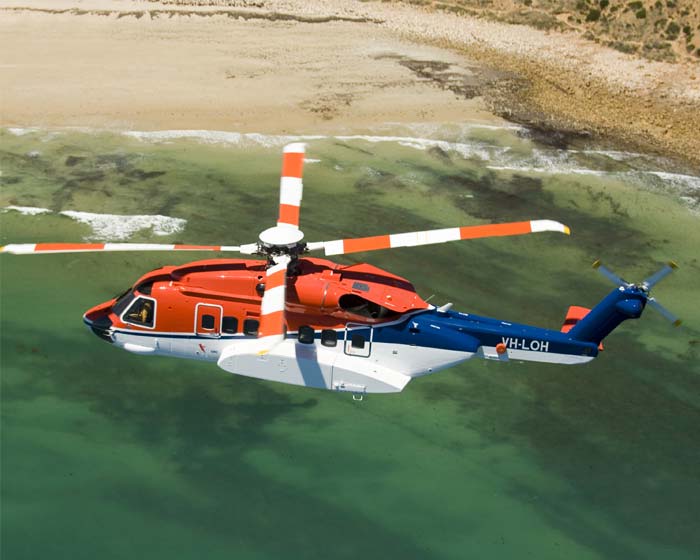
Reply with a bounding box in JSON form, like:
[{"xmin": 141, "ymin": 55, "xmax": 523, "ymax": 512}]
[{"xmin": 0, "ymin": 243, "xmax": 257, "ymax": 255}]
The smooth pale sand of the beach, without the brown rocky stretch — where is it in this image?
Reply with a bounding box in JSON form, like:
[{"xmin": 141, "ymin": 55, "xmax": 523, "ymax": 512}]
[{"xmin": 0, "ymin": 2, "xmax": 504, "ymax": 133}]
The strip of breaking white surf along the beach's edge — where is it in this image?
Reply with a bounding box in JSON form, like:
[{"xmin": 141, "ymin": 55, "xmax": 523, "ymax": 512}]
[{"xmin": 0, "ymin": 123, "xmax": 700, "ymax": 210}]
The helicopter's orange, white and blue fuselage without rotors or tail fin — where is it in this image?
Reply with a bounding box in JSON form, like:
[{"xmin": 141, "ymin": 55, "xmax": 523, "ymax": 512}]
[{"xmin": 84, "ymin": 258, "xmax": 598, "ymax": 394}]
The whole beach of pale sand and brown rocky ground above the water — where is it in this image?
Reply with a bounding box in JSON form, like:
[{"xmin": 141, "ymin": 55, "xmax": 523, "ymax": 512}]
[{"xmin": 0, "ymin": 0, "xmax": 700, "ymax": 165}]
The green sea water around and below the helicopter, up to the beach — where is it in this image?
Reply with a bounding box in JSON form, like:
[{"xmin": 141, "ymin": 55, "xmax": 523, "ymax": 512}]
[{"xmin": 0, "ymin": 126, "xmax": 700, "ymax": 559}]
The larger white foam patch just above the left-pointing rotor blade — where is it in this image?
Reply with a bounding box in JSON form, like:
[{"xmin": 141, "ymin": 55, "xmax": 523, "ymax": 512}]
[{"xmin": 61, "ymin": 210, "xmax": 187, "ymax": 240}]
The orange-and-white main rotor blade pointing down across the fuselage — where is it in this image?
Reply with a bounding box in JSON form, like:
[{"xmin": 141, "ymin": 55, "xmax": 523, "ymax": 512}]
[{"xmin": 255, "ymin": 255, "xmax": 291, "ymax": 354}]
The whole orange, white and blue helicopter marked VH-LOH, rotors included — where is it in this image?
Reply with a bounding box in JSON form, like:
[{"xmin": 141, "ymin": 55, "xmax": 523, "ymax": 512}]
[{"xmin": 0, "ymin": 143, "xmax": 680, "ymax": 399}]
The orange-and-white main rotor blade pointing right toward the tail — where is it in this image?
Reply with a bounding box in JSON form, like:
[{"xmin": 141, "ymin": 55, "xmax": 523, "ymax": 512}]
[{"xmin": 308, "ymin": 220, "xmax": 571, "ymax": 256}]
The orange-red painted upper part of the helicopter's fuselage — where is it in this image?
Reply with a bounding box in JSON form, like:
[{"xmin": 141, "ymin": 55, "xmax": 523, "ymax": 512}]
[{"xmin": 87, "ymin": 258, "xmax": 428, "ymax": 334}]
